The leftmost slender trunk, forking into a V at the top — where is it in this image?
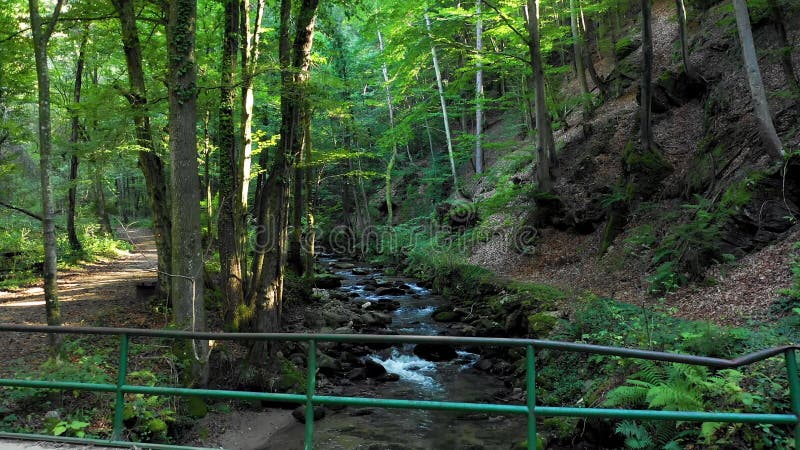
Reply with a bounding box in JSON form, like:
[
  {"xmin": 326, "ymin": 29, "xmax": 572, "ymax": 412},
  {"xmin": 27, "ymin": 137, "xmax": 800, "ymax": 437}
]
[{"xmin": 28, "ymin": 0, "xmax": 62, "ymax": 356}]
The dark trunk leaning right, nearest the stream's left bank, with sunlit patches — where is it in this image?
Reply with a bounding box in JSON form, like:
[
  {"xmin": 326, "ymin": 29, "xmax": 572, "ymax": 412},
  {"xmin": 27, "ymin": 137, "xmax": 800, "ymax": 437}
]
[{"xmin": 250, "ymin": 0, "xmax": 319, "ymax": 365}]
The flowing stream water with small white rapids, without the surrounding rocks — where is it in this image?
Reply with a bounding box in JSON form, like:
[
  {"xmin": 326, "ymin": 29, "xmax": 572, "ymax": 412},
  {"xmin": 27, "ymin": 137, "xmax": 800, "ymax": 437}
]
[{"xmin": 263, "ymin": 260, "xmax": 525, "ymax": 450}]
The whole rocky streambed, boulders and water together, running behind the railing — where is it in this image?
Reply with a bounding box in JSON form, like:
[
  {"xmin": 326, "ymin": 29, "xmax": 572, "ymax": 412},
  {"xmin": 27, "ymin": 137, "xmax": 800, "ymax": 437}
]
[{"xmin": 261, "ymin": 259, "xmax": 525, "ymax": 450}]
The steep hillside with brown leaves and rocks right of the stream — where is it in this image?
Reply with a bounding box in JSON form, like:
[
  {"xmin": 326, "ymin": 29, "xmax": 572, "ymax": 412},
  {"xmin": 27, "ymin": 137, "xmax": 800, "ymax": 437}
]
[{"xmin": 470, "ymin": 1, "xmax": 800, "ymax": 324}]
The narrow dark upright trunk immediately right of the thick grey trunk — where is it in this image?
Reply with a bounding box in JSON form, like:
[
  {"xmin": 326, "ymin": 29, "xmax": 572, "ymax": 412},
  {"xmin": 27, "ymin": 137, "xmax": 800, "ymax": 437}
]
[{"xmin": 217, "ymin": 0, "xmax": 244, "ymax": 330}]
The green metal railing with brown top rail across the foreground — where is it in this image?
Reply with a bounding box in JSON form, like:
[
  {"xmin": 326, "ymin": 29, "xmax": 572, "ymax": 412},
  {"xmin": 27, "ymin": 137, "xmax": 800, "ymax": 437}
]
[{"xmin": 0, "ymin": 324, "xmax": 800, "ymax": 450}]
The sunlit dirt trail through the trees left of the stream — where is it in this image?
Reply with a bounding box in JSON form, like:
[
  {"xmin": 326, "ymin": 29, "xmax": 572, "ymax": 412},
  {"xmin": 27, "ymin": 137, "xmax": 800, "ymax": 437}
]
[{"xmin": 0, "ymin": 229, "xmax": 168, "ymax": 376}]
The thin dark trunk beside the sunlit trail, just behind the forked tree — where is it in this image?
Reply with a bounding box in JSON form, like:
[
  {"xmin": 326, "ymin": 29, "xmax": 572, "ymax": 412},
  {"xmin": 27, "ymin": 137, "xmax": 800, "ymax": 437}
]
[{"xmin": 67, "ymin": 31, "xmax": 87, "ymax": 253}]
